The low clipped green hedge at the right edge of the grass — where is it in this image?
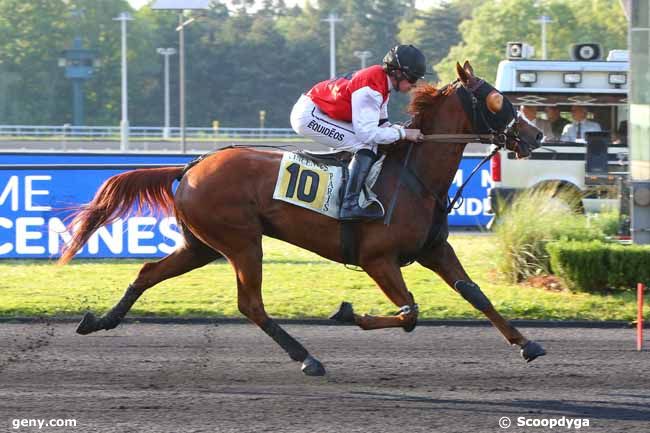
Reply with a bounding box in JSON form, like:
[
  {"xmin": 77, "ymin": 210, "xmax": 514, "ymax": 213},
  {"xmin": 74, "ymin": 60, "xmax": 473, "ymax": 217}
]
[{"xmin": 546, "ymin": 241, "xmax": 650, "ymax": 291}]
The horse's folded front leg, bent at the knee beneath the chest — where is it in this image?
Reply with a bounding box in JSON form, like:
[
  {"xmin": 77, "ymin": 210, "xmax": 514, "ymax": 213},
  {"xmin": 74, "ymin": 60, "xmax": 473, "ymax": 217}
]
[{"xmin": 330, "ymin": 259, "xmax": 418, "ymax": 332}]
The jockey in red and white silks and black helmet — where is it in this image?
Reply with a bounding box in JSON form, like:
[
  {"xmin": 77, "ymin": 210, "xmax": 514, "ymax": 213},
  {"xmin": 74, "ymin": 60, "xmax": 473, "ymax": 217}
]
[{"xmin": 291, "ymin": 45, "xmax": 426, "ymax": 221}]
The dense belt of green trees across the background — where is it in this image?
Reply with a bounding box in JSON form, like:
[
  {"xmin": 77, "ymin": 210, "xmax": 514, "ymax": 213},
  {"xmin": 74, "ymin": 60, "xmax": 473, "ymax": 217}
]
[{"xmin": 0, "ymin": 0, "xmax": 627, "ymax": 127}]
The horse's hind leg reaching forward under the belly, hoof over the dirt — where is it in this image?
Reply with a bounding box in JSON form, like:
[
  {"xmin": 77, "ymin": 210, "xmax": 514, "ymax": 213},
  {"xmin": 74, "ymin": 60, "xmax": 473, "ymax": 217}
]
[{"xmin": 228, "ymin": 239, "xmax": 325, "ymax": 376}]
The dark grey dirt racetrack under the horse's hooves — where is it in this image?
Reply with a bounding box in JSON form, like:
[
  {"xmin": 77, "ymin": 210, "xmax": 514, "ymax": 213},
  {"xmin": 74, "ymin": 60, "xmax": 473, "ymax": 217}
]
[{"xmin": 0, "ymin": 323, "xmax": 650, "ymax": 433}]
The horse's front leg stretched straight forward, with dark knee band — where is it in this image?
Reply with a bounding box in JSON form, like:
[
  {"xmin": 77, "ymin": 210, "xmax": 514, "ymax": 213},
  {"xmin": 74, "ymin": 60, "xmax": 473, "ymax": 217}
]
[{"xmin": 418, "ymin": 241, "xmax": 546, "ymax": 362}]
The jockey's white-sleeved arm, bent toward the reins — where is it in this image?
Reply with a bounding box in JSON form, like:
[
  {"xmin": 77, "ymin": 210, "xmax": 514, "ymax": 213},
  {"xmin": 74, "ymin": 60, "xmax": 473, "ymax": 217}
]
[{"xmin": 352, "ymin": 87, "xmax": 406, "ymax": 144}]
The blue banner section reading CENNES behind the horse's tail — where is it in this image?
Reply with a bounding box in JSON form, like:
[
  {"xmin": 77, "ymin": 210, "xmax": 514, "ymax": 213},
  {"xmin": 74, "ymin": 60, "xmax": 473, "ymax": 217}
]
[{"xmin": 0, "ymin": 168, "xmax": 181, "ymax": 258}]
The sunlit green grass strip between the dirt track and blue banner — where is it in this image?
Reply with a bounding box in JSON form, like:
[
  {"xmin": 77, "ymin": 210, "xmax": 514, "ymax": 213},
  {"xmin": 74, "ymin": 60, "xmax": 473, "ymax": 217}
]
[{"xmin": 0, "ymin": 234, "xmax": 635, "ymax": 320}]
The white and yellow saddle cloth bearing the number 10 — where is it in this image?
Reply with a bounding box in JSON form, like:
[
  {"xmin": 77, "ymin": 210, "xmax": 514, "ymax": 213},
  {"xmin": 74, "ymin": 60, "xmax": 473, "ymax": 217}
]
[{"xmin": 273, "ymin": 152, "xmax": 386, "ymax": 219}]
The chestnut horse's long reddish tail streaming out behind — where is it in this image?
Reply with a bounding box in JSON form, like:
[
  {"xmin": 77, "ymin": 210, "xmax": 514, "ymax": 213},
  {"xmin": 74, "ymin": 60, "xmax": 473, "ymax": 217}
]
[{"xmin": 59, "ymin": 167, "xmax": 183, "ymax": 265}]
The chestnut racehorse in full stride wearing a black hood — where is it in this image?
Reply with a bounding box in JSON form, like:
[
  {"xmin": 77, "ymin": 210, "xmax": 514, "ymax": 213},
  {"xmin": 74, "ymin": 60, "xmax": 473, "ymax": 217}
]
[{"xmin": 60, "ymin": 62, "xmax": 545, "ymax": 376}]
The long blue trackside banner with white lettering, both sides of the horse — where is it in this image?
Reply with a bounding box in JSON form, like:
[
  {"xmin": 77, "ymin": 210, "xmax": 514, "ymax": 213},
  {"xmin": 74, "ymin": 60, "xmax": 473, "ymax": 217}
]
[{"xmin": 0, "ymin": 154, "xmax": 491, "ymax": 258}]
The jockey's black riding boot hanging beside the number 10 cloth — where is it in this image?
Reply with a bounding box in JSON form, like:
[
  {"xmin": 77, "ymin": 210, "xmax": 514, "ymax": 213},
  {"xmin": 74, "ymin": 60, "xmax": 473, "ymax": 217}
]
[{"xmin": 339, "ymin": 149, "xmax": 384, "ymax": 221}]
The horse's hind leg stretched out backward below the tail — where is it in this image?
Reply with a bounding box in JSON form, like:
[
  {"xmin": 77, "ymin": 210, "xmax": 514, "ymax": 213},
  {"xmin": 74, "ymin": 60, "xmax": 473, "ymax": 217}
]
[{"xmin": 77, "ymin": 232, "xmax": 219, "ymax": 335}]
